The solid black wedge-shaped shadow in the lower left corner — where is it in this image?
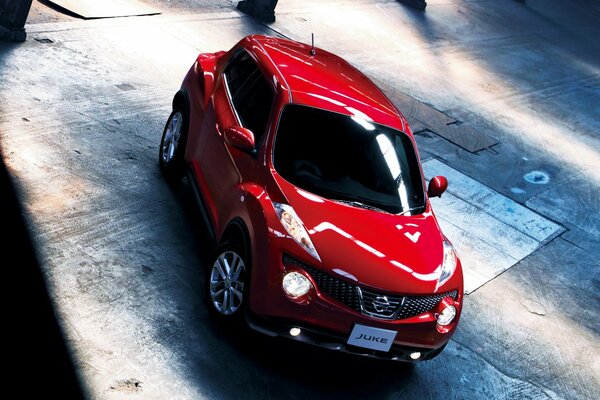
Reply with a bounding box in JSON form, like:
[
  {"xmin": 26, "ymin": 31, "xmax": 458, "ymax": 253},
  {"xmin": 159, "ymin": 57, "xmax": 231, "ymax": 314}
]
[{"xmin": 0, "ymin": 149, "xmax": 84, "ymax": 399}]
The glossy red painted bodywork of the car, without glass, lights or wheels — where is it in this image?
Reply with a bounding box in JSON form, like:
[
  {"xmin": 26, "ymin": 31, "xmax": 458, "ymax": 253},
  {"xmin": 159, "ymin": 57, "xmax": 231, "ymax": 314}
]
[{"xmin": 164, "ymin": 35, "xmax": 463, "ymax": 359}]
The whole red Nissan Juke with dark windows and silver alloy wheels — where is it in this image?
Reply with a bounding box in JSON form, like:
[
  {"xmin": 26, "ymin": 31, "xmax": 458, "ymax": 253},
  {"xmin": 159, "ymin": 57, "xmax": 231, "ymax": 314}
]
[{"xmin": 160, "ymin": 35, "xmax": 463, "ymax": 361}]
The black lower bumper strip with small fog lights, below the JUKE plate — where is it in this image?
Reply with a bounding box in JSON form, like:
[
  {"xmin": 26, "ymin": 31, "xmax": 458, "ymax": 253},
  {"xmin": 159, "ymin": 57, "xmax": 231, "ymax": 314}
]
[{"xmin": 245, "ymin": 311, "xmax": 446, "ymax": 362}]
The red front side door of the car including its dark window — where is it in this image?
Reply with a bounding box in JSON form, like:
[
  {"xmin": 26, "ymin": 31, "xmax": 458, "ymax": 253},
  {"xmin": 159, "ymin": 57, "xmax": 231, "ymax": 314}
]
[{"xmin": 201, "ymin": 50, "xmax": 274, "ymax": 232}]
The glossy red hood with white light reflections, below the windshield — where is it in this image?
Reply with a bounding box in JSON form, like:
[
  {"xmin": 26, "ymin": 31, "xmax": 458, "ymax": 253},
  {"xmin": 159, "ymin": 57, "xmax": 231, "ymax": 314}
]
[{"xmin": 279, "ymin": 177, "xmax": 443, "ymax": 293}]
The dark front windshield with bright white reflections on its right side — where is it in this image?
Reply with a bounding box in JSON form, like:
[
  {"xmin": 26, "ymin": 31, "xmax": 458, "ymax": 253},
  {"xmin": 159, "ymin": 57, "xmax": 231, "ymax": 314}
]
[{"xmin": 273, "ymin": 104, "xmax": 425, "ymax": 214}]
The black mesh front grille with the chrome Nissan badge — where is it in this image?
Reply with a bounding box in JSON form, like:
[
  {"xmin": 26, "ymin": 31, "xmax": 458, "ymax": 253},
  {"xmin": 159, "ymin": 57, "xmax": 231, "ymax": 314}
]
[{"xmin": 283, "ymin": 254, "xmax": 458, "ymax": 319}]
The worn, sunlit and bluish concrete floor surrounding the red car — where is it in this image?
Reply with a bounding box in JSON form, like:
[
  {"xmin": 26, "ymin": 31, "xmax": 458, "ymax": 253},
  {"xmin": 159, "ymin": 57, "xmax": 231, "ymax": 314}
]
[{"xmin": 0, "ymin": 0, "xmax": 600, "ymax": 399}]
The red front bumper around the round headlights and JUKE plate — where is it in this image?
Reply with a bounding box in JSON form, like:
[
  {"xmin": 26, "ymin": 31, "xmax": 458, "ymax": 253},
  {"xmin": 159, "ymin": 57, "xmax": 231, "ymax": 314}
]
[{"xmin": 248, "ymin": 231, "xmax": 463, "ymax": 361}]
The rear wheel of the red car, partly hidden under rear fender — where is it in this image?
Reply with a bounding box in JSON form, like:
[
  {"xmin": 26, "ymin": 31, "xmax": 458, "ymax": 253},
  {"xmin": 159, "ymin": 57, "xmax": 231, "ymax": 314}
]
[{"xmin": 158, "ymin": 106, "xmax": 189, "ymax": 184}]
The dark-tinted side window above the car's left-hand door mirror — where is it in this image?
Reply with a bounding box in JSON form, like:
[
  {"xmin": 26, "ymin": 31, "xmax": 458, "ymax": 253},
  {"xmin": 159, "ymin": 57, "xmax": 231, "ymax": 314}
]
[{"xmin": 225, "ymin": 52, "xmax": 274, "ymax": 145}]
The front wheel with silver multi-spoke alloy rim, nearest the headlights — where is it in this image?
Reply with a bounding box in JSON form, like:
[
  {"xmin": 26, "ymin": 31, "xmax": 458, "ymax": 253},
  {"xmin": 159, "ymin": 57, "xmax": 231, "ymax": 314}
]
[{"xmin": 206, "ymin": 242, "xmax": 250, "ymax": 323}]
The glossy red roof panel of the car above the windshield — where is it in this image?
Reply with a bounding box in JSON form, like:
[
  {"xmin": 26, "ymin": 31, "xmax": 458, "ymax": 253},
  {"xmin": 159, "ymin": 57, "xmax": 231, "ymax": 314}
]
[{"xmin": 250, "ymin": 35, "xmax": 406, "ymax": 132}]
